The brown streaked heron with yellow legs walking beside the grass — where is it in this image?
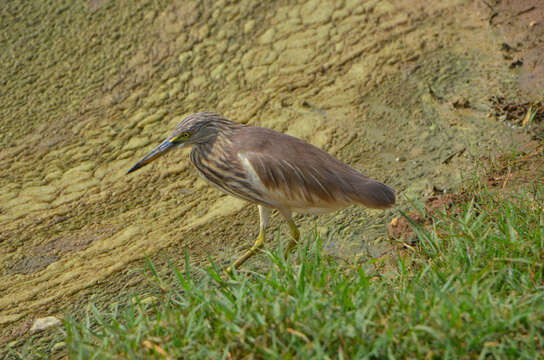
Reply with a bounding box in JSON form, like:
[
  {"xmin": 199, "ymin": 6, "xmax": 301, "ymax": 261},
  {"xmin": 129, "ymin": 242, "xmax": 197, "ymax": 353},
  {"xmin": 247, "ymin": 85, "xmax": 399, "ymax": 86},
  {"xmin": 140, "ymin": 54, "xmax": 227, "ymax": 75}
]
[{"xmin": 127, "ymin": 112, "xmax": 395, "ymax": 273}]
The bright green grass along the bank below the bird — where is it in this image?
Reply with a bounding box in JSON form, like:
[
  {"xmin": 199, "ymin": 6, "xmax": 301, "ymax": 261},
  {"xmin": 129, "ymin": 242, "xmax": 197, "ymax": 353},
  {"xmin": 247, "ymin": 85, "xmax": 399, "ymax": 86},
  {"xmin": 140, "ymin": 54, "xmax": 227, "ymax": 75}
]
[{"xmin": 54, "ymin": 187, "xmax": 544, "ymax": 359}]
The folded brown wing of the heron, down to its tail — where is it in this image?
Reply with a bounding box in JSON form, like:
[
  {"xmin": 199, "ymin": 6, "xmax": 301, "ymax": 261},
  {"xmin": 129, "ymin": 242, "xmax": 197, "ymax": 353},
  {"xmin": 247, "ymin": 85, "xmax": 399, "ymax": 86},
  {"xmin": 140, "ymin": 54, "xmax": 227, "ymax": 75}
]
[{"xmin": 233, "ymin": 127, "xmax": 395, "ymax": 208}]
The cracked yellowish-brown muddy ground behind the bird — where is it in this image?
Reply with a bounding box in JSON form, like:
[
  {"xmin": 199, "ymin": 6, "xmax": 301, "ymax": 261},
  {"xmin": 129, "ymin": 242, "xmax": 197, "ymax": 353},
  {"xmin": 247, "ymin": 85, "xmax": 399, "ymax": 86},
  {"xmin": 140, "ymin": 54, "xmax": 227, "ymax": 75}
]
[{"xmin": 0, "ymin": 0, "xmax": 544, "ymax": 356}]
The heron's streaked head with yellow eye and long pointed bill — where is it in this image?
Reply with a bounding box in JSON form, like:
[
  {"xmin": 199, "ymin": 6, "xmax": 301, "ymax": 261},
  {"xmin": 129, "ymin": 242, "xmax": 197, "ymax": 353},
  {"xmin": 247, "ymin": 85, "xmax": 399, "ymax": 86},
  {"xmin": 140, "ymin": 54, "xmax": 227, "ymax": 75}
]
[{"xmin": 127, "ymin": 112, "xmax": 229, "ymax": 174}]
